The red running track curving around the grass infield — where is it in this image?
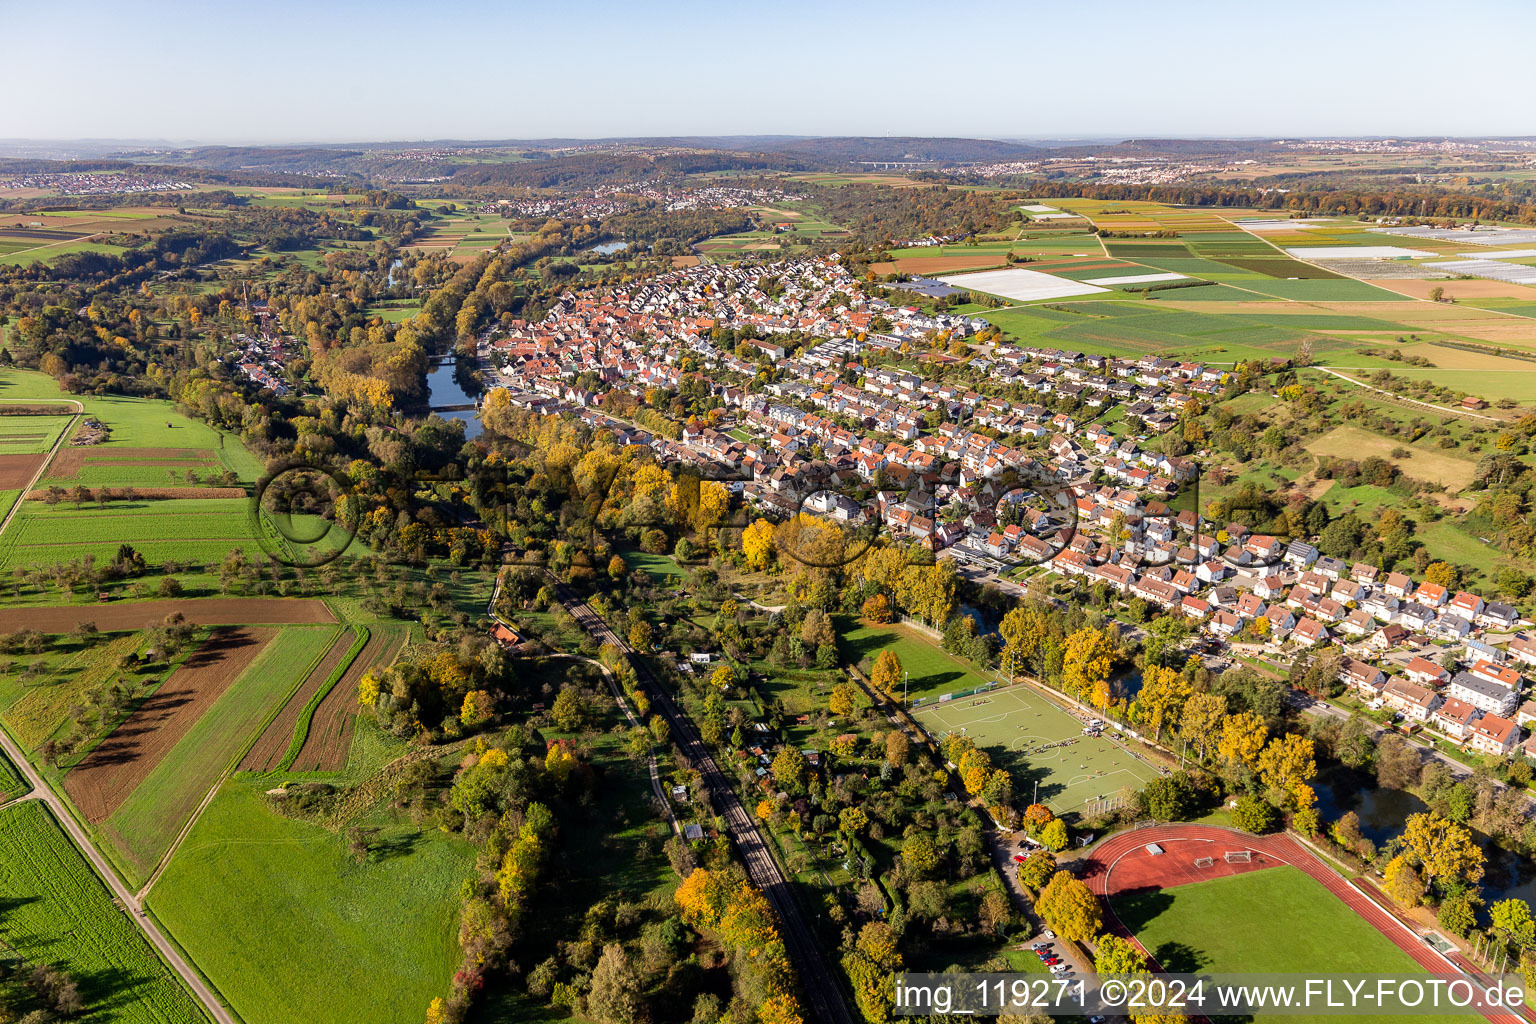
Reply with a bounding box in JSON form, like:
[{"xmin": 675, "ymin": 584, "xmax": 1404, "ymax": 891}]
[{"xmin": 1081, "ymin": 824, "xmax": 1530, "ymax": 1024}]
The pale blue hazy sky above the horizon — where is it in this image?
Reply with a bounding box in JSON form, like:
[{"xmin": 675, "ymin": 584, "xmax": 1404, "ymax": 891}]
[{"xmin": 0, "ymin": 0, "xmax": 1536, "ymax": 141}]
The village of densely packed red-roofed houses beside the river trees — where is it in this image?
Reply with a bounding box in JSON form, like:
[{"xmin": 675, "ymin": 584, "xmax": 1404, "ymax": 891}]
[{"xmin": 481, "ymin": 256, "xmax": 1536, "ymax": 776}]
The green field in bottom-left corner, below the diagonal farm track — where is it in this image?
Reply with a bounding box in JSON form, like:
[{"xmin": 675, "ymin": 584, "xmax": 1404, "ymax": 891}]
[{"xmin": 0, "ymin": 801, "xmax": 207, "ymax": 1024}]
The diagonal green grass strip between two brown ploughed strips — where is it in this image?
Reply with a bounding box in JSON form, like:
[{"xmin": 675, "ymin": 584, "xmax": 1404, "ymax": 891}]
[{"xmin": 101, "ymin": 626, "xmax": 339, "ymax": 886}]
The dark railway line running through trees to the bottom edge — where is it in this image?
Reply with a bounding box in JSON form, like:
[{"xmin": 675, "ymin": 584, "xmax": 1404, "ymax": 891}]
[{"xmin": 551, "ymin": 576, "xmax": 854, "ymax": 1024}]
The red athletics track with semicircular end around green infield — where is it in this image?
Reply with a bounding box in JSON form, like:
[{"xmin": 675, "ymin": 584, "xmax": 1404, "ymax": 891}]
[{"xmin": 1080, "ymin": 824, "xmax": 1528, "ymax": 1024}]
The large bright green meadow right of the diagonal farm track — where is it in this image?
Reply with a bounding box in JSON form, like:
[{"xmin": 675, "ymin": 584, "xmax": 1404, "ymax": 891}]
[{"xmin": 149, "ymin": 780, "xmax": 475, "ymax": 1024}]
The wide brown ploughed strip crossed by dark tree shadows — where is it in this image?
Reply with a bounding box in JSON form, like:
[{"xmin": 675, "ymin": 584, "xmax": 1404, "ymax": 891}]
[{"xmin": 65, "ymin": 628, "xmax": 278, "ymax": 824}]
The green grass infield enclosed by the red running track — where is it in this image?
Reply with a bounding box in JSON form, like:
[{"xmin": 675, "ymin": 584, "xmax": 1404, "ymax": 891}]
[{"xmin": 1112, "ymin": 866, "xmax": 1465, "ymax": 1021}]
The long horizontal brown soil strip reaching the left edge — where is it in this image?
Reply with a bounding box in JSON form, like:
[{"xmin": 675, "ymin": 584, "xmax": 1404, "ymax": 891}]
[{"xmin": 0, "ymin": 597, "xmax": 336, "ymax": 633}]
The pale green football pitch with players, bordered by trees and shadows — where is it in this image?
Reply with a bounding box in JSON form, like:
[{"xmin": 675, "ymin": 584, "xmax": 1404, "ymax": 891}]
[{"xmin": 912, "ymin": 686, "xmax": 1161, "ymax": 815}]
